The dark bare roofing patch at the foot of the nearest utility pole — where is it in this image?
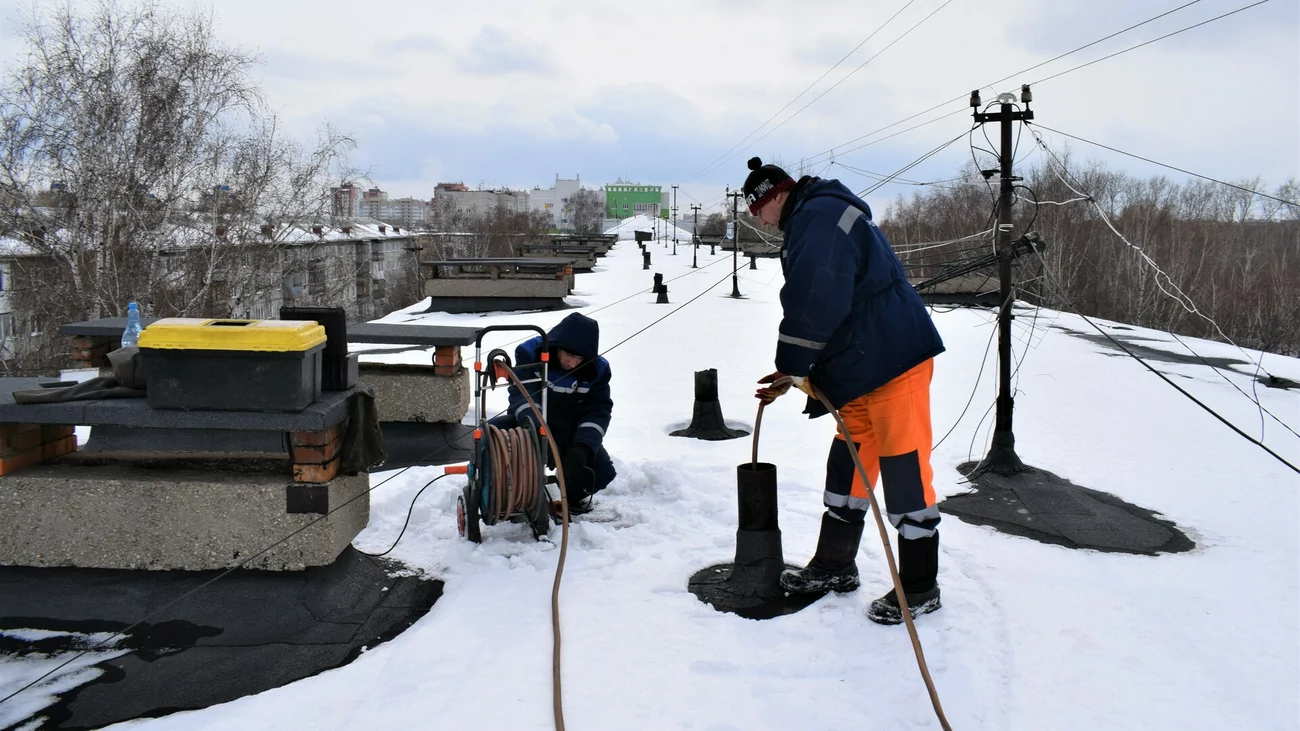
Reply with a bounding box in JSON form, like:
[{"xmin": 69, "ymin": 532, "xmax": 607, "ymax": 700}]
[{"xmin": 939, "ymin": 462, "xmax": 1195, "ymax": 555}]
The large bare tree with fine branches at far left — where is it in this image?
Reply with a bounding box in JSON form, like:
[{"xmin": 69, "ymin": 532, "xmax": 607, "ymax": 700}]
[{"xmin": 0, "ymin": 0, "xmax": 354, "ymax": 369}]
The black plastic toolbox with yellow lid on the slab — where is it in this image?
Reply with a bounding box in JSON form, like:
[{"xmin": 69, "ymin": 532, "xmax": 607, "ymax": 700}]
[{"xmin": 139, "ymin": 317, "xmax": 325, "ymax": 411}]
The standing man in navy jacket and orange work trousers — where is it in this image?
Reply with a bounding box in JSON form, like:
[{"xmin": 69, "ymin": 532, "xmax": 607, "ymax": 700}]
[{"xmin": 744, "ymin": 157, "xmax": 944, "ymax": 624}]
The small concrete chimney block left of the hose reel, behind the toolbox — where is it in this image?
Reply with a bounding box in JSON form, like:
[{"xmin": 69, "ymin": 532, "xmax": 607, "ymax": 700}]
[{"xmin": 359, "ymin": 363, "xmax": 469, "ymax": 423}]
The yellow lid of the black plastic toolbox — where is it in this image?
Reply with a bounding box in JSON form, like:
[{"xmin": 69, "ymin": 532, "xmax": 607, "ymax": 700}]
[{"xmin": 139, "ymin": 317, "xmax": 325, "ymax": 352}]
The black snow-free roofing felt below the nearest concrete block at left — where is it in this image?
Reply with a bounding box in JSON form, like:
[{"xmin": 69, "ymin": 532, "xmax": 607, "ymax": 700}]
[{"xmin": 0, "ymin": 548, "xmax": 442, "ymax": 730}]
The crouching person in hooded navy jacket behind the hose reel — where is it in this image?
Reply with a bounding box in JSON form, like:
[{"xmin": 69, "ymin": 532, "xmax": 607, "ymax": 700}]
[{"xmin": 491, "ymin": 312, "xmax": 615, "ymax": 515}]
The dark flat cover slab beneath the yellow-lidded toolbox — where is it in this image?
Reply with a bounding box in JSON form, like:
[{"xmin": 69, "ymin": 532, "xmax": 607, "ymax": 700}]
[{"xmin": 0, "ymin": 379, "xmax": 355, "ymax": 432}]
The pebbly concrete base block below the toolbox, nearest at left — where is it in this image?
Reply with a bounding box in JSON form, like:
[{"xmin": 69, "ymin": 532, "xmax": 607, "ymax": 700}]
[{"xmin": 0, "ymin": 463, "xmax": 371, "ymax": 571}]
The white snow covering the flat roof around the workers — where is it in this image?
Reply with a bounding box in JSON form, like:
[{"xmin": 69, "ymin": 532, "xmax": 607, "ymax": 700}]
[{"xmin": 12, "ymin": 236, "xmax": 1300, "ymax": 731}]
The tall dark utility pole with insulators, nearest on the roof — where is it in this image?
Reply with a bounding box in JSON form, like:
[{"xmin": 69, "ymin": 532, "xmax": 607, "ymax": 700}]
[{"xmin": 970, "ymin": 85, "xmax": 1034, "ymax": 475}]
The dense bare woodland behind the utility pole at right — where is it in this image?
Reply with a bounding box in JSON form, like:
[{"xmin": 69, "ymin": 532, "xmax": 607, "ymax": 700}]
[{"xmin": 880, "ymin": 152, "xmax": 1300, "ymax": 355}]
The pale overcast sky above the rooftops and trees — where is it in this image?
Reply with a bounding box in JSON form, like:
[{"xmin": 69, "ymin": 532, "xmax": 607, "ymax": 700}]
[{"xmin": 0, "ymin": 0, "xmax": 1300, "ymax": 211}]
